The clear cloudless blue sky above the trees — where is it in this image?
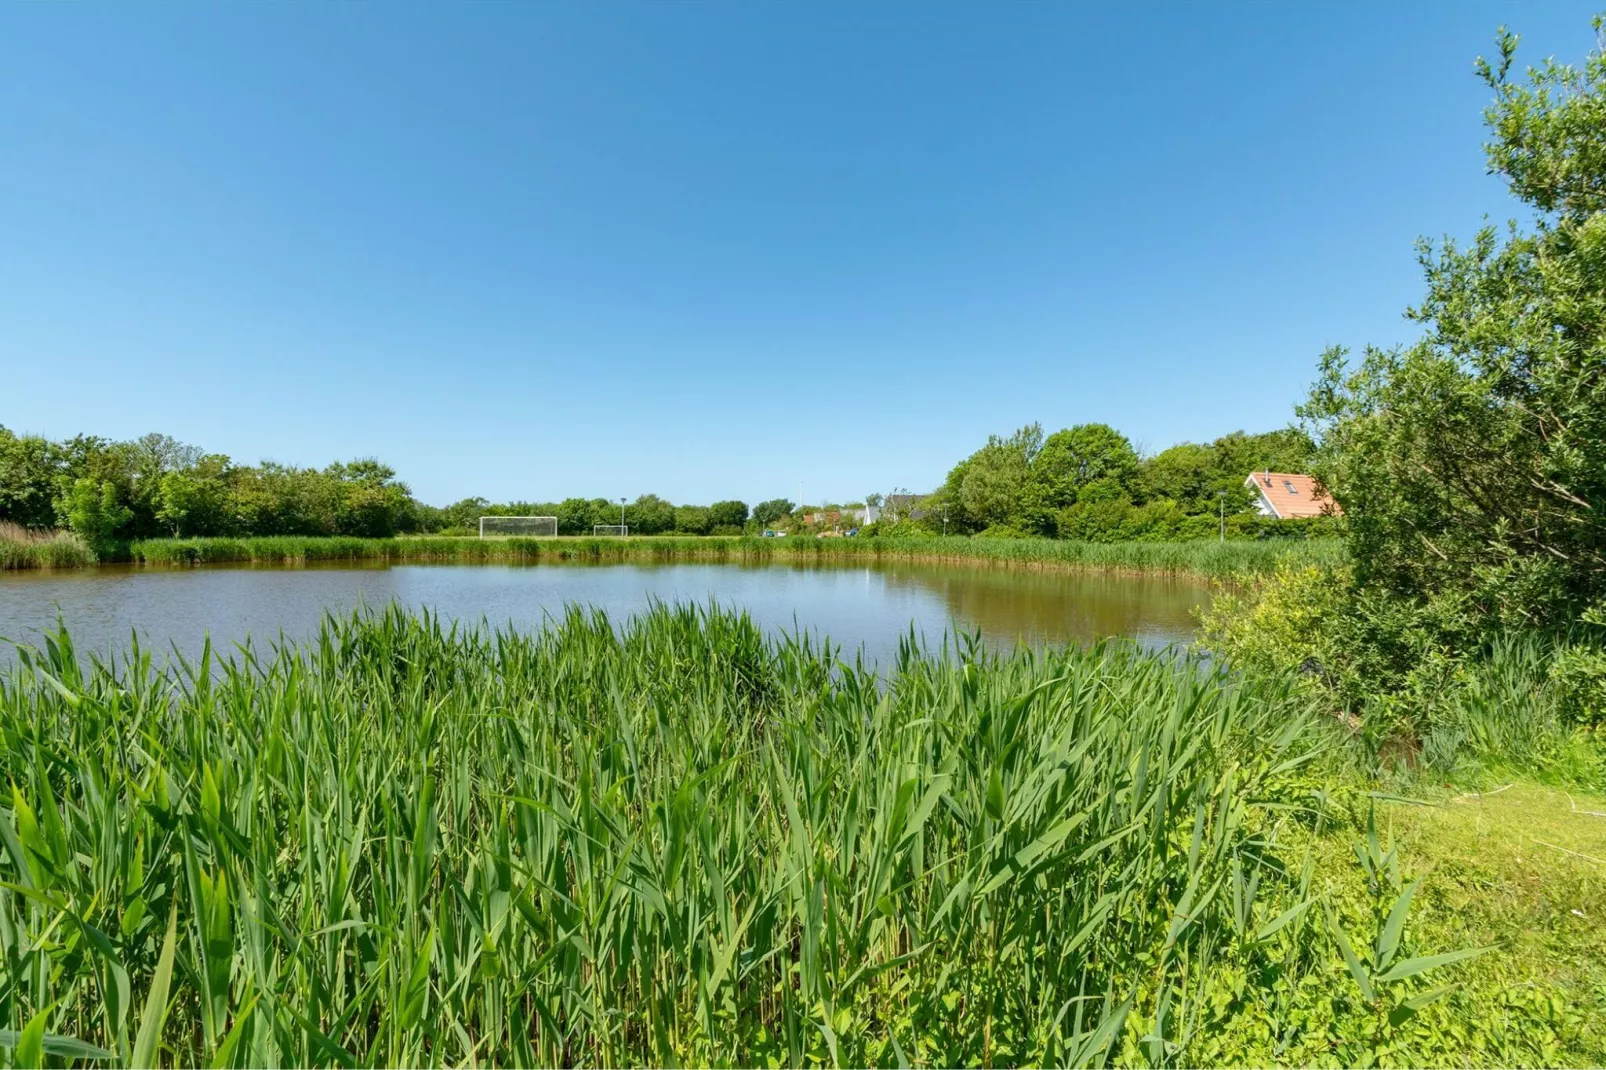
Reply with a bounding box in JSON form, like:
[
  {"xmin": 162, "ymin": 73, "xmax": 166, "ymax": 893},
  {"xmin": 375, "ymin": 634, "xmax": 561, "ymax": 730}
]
[{"xmin": 0, "ymin": 0, "xmax": 1592, "ymax": 503}]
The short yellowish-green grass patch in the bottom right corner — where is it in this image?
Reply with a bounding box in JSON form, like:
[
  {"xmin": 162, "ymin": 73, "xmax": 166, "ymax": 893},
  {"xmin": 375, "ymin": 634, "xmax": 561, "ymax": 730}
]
[{"xmin": 1284, "ymin": 779, "xmax": 1606, "ymax": 1067}]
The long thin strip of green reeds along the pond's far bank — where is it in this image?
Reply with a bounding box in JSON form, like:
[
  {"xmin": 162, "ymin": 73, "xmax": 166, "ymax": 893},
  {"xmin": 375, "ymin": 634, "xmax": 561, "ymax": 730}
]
[{"xmin": 130, "ymin": 537, "xmax": 1343, "ymax": 577}]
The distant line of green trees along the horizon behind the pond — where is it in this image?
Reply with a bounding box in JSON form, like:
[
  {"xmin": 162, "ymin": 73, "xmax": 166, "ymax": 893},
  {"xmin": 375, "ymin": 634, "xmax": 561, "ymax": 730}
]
[{"xmin": 0, "ymin": 414, "xmax": 1312, "ymax": 554}]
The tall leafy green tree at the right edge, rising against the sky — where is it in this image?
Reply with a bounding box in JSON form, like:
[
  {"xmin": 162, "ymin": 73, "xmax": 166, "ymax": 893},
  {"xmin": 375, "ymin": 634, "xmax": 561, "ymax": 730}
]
[{"xmin": 1301, "ymin": 19, "xmax": 1606, "ymax": 631}]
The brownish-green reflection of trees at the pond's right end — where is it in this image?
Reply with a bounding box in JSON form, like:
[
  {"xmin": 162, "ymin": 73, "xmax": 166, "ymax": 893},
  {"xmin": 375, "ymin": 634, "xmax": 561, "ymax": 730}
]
[{"xmin": 874, "ymin": 566, "xmax": 1209, "ymax": 643}]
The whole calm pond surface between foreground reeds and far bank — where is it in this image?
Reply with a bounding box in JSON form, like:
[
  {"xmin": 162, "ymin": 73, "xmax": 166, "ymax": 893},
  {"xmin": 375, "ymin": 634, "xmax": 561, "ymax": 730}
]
[{"xmin": 0, "ymin": 564, "xmax": 1208, "ymax": 662}]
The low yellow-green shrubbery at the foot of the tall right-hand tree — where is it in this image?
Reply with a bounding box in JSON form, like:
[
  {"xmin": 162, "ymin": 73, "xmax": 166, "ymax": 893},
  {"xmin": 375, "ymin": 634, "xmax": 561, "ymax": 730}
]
[{"xmin": 1200, "ymin": 566, "xmax": 1606, "ymax": 774}]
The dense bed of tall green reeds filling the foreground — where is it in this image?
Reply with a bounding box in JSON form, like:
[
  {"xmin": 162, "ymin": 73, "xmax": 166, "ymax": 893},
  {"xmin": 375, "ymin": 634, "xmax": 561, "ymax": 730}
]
[{"xmin": 0, "ymin": 606, "xmax": 1312, "ymax": 1067}]
